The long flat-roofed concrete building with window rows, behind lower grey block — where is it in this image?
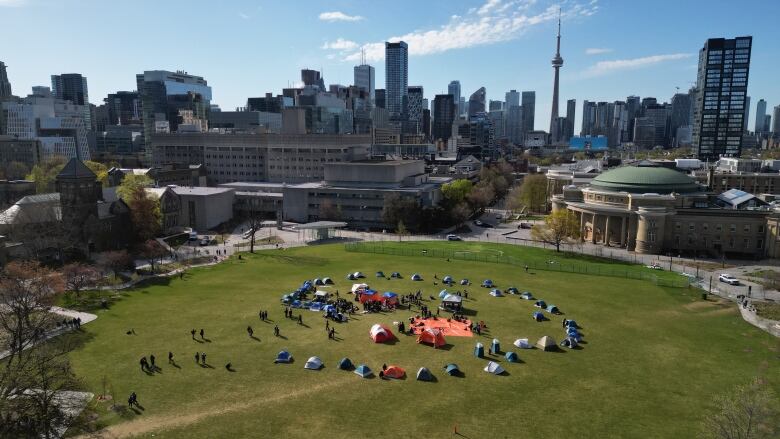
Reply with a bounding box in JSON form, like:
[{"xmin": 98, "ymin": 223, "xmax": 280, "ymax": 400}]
[{"xmin": 152, "ymin": 133, "xmax": 371, "ymax": 184}]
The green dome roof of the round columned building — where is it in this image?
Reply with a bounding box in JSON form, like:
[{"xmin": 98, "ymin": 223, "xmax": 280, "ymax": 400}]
[{"xmin": 591, "ymin": 163, "xmax": 701, "ymax": 194}]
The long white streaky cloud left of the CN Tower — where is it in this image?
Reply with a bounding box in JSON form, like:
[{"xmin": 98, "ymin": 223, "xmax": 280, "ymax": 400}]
[{"xmin": 320, "ymin": 0, "xmax": 597, "ymax": 61}]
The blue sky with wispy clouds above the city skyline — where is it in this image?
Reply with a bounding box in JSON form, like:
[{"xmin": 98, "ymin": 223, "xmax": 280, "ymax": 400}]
[{"xmin": 0, "ymin": 0, "xmax": 780, "ymax": 134}]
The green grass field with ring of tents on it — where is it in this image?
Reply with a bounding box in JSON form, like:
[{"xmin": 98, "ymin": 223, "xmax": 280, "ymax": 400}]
[{"xmin": 65, "ymin": 243, "xmax": 780, "ymax": 438}]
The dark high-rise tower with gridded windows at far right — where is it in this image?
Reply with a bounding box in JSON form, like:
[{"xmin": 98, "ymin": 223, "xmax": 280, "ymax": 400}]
[{"xmin": 693, "ymin": 37, "xmax": 753, "ymax": 160}]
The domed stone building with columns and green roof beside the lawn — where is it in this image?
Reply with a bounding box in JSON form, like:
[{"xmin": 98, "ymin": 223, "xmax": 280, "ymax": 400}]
[{"xmin": 548, "ymin": 161, "xmax": 773, "ymax": 256}]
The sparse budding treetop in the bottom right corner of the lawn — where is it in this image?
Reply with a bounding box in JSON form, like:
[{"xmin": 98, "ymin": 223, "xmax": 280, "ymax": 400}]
[{"xmin": 702, "ymin": 378, "xmax": 780, "ymax": 439}]
